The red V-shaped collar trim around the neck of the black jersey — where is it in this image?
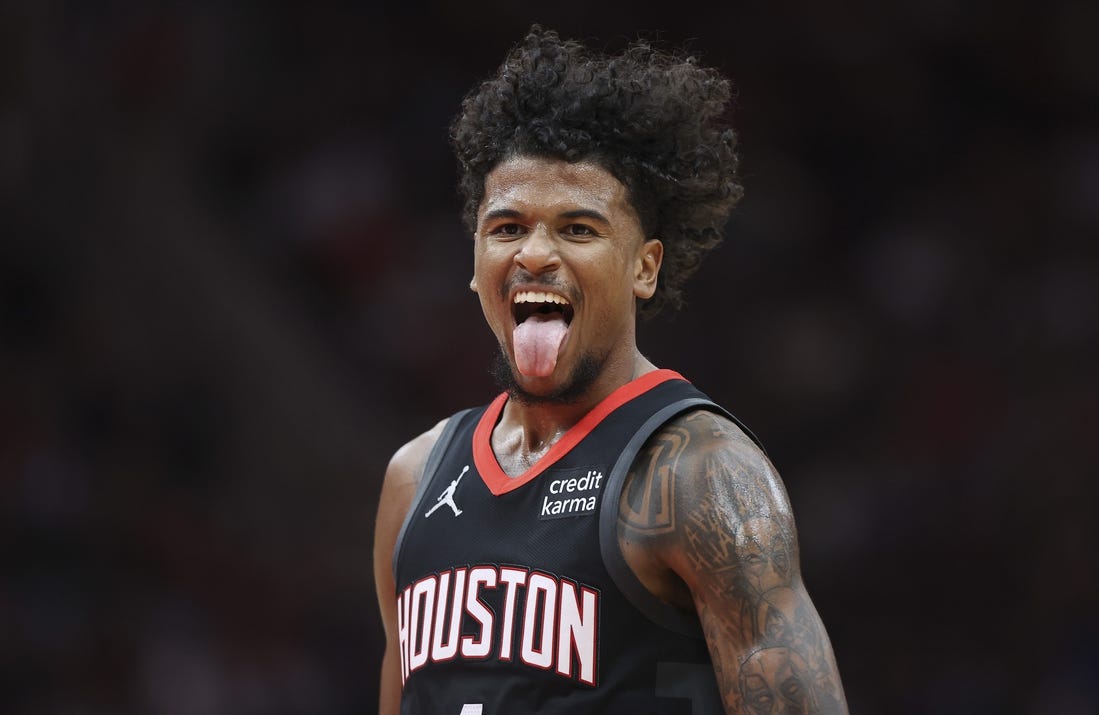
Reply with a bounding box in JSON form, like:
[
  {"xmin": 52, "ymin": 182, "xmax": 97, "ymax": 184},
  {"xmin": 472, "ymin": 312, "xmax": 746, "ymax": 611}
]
[{"xmin": 474, "ymin": 370, "xmax": 686, "ymax": 496}]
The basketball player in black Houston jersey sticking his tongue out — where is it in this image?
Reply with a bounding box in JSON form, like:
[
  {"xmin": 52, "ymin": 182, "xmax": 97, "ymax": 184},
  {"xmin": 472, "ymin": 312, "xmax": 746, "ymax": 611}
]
[{"xmin": 375, "ymin": 26, "xmax": 846, "ymax": 715}]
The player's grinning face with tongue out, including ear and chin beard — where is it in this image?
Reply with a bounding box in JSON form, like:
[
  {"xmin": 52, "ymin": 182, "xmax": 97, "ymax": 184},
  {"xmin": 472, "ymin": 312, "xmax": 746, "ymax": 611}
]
[{"xmin": 470, "ymin": 156, "xmax": 663, "ymax": 398}]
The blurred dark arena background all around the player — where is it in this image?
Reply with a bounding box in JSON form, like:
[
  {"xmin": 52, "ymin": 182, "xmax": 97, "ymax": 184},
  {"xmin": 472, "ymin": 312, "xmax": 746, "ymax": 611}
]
[{"xmin": 0, "ymin": 0, "xmax": 1099, "ymax": 715}]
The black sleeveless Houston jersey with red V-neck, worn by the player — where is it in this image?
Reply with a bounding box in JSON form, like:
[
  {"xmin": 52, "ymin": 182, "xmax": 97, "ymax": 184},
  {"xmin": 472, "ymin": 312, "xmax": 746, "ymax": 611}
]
[{"xmin": 393, "ymin": 370, "xmax": 764, "ymax": 715}]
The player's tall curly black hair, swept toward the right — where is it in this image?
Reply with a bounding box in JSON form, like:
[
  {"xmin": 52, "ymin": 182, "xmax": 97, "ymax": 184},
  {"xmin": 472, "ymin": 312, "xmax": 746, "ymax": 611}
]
[{"xmin": 451, "ymin": 25, "xmax": 743, "ymax": 316}]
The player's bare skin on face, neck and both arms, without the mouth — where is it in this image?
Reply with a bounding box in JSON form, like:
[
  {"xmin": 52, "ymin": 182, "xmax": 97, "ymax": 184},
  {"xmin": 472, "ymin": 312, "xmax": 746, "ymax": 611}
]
[{"xmin": 375, "ymin": 156, "xmax": 846, "ymax": 715}]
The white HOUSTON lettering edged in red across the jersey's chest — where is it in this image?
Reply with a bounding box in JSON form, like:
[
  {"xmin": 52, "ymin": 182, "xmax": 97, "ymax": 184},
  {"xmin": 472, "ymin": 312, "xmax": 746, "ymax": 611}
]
[{"xmin": 397, "ymin": 566, "xmax": 599, "ymax": 685}]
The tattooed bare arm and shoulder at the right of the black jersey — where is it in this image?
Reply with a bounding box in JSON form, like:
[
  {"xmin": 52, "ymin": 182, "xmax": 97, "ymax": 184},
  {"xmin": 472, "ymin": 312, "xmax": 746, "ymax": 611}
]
[{"xmin": 619, "ymin": 412, "xmax": 847, "ymax": 715}]
